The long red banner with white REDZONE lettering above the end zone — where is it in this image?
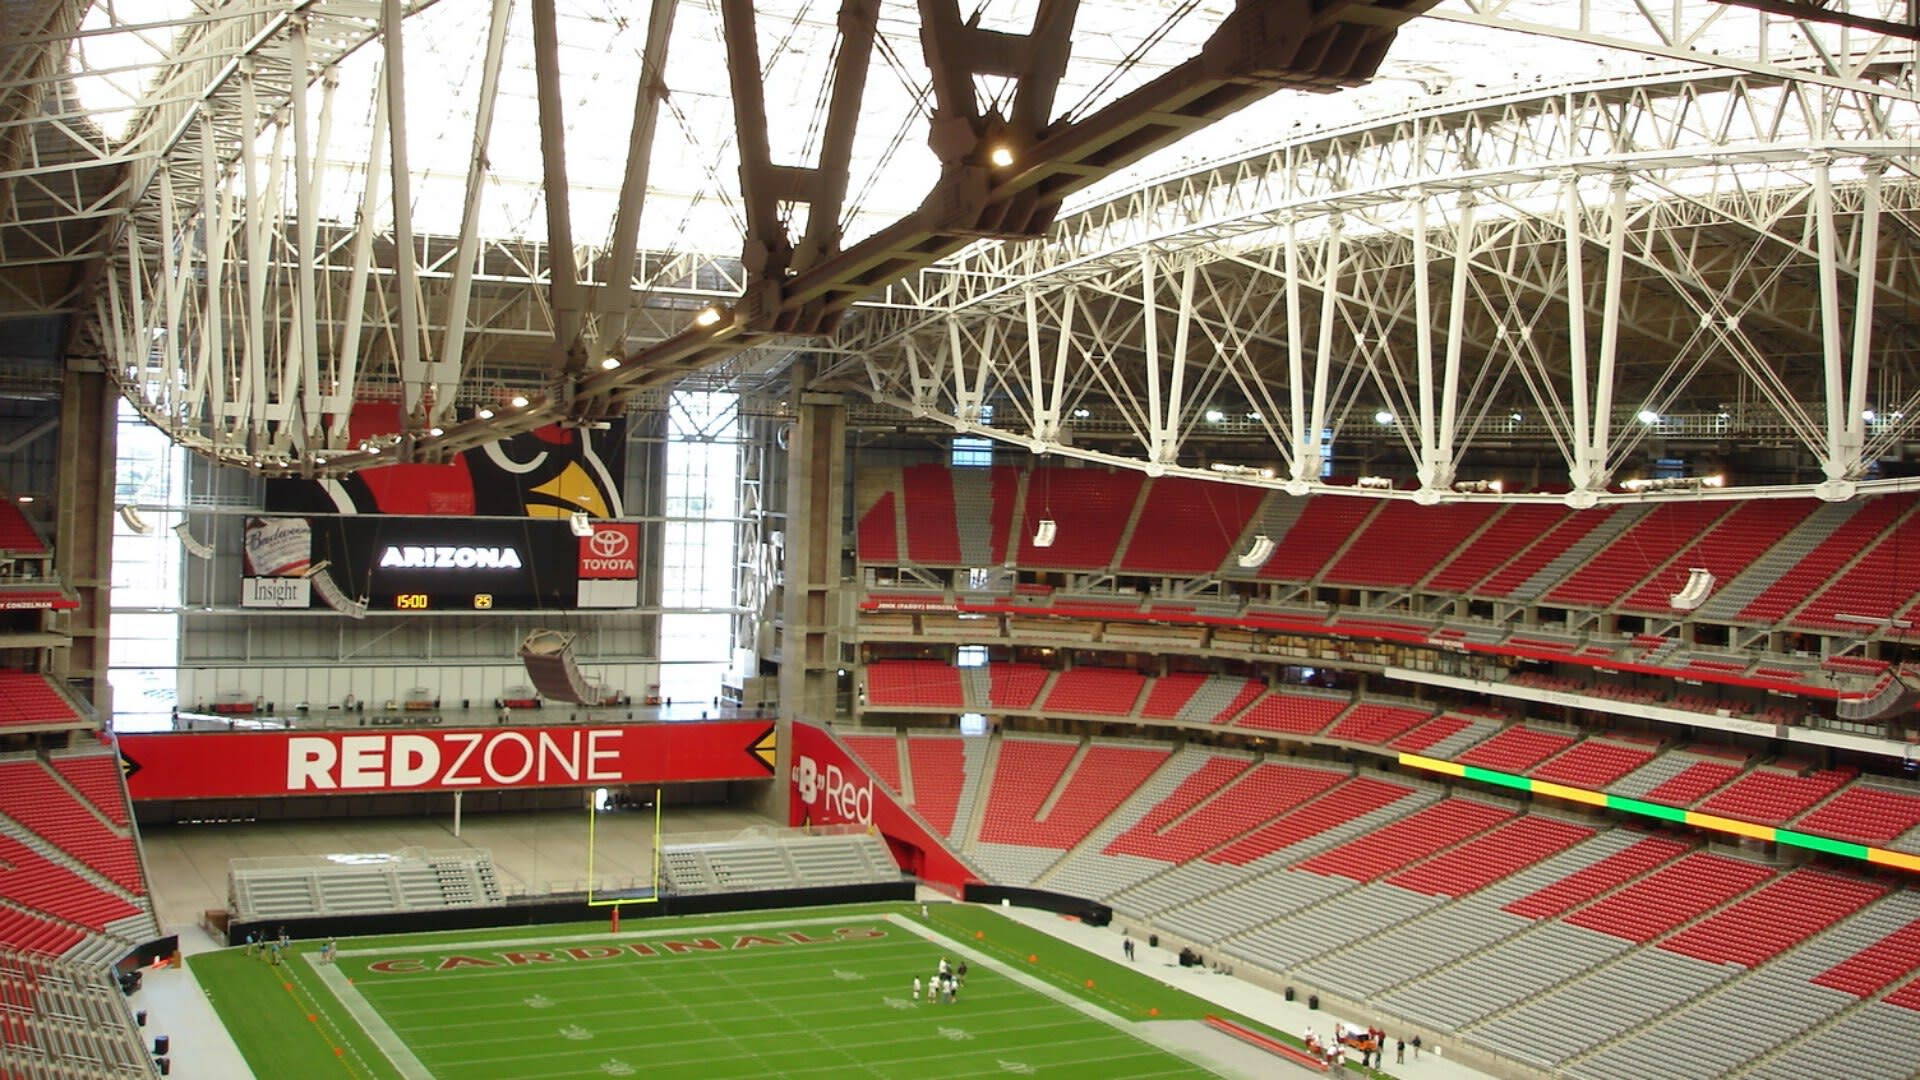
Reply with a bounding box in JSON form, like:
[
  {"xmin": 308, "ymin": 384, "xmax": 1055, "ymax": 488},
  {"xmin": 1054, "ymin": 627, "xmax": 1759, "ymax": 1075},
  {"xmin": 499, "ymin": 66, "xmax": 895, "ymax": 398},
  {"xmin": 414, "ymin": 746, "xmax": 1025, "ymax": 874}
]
[{"xmin": 119, "ymin": 721, "xmax": 774, "ymax": 799}]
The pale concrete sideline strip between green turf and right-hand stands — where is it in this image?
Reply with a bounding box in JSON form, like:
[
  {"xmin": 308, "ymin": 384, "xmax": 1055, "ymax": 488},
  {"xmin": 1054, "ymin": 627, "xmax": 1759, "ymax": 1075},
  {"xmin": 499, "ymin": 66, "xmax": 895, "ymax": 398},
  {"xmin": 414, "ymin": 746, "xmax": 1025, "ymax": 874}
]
[{"xmin": 983, "ymin": 890, "xmax": 1492, "ymax": 1080}]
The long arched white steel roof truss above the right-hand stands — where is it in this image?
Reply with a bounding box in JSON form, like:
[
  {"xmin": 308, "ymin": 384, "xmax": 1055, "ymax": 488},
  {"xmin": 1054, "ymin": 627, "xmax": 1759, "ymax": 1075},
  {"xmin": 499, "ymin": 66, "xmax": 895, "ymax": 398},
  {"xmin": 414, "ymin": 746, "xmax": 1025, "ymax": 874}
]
[{"xmin": 835, "ymin": 65, "xmax": 1920, "ymax": 505}]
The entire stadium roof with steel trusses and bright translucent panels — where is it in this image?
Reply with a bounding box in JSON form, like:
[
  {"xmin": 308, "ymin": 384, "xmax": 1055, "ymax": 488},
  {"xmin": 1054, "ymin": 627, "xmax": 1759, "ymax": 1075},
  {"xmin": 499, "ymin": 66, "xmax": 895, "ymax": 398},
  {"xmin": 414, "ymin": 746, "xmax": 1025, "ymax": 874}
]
[{"xmin": 11, "ymin": 0, "xmax": 1920, "ymax": 503}]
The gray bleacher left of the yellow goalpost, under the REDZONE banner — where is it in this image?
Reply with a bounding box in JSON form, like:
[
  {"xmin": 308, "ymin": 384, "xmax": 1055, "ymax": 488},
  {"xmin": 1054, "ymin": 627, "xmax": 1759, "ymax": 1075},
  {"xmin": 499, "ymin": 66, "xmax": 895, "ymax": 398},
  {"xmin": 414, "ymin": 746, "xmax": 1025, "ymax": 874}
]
[{"xmin": 227, "ymin": 847, "xmax": 505, "ymax": 922}]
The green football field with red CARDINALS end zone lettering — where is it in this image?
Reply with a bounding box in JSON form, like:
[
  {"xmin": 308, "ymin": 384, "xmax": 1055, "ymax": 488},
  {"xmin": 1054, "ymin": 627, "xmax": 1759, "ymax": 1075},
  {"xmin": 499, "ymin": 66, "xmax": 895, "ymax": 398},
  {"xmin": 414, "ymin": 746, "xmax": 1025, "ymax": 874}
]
[{"xmin": 192, "ymin": 905, "xmax": 1305, "ymax": 1080}]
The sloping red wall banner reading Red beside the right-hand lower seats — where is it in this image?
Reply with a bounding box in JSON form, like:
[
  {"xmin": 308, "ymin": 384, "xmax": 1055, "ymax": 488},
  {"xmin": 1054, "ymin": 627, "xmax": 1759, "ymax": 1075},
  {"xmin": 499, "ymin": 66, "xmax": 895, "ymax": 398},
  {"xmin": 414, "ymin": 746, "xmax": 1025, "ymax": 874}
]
[{"xmin": 787, "ymin": 723, "xmax": 979, "ymax": 890}]
